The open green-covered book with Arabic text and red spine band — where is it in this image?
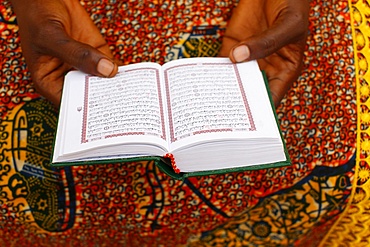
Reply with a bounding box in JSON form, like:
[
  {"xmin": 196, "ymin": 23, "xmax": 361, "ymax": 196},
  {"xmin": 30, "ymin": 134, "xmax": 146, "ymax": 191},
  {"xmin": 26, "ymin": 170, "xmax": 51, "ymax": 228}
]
[{"xmin": 52, "ymin": 58, "xmax": 290, "ymax": 178}]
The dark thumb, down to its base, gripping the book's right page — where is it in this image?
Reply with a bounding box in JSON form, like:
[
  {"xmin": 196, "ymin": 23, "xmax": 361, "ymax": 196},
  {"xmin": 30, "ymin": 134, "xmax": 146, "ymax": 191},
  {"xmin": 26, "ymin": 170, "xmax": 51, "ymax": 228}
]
[{"xmin": 228, "ymin": 0, "xmax": 309, "ymax": 62}]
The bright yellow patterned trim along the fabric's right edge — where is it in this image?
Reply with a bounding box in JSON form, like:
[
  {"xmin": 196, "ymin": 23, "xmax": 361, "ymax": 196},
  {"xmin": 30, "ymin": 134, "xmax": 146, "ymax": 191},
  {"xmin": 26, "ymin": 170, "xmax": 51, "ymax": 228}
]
[{"xmin": 320, "ymin": 1, "xmax": 370, "ymax": 247}]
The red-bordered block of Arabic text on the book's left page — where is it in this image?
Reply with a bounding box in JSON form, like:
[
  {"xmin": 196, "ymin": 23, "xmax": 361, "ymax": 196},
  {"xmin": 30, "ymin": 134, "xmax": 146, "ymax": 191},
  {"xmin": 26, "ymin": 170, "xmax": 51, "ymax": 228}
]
[{"xmin": 81, "ymin": 67, "xmax": 166, "ymax": 143}]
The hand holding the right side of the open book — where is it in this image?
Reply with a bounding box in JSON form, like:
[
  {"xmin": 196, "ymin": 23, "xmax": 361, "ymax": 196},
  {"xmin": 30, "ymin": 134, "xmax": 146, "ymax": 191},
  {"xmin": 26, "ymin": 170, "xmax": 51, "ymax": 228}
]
[{"xmin": 219, "ymin": 0, "xmax": 309, "ymax": 106}]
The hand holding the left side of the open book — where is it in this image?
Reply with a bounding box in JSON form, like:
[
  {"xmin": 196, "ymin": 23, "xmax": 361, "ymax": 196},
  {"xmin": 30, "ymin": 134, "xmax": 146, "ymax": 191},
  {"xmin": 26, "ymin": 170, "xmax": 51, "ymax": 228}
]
[{"xmin": 11, "ymin": 0, "xmax": 118, "ymax": 106}]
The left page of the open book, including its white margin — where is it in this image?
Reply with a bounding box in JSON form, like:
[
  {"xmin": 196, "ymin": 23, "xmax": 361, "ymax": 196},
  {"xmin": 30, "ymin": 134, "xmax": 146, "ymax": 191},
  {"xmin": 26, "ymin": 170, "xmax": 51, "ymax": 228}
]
[{"xmin": 53, "ymin": 63, "xmax": 166, "ymax": 161}]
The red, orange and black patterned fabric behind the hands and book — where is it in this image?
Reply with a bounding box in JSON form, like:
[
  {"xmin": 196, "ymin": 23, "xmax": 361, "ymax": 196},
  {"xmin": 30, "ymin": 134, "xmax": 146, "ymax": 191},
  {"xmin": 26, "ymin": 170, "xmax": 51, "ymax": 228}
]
[{"xmin": 0, "ymin": 0, "xmax": 364, "ymax": 246}]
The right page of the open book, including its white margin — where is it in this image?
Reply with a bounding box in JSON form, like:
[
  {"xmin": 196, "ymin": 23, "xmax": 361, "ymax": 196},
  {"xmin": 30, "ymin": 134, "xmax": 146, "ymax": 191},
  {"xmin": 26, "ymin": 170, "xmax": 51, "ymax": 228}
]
[{"xmin": 163, "ymin": 58, "xmax": 279, "ymax": 151}]
